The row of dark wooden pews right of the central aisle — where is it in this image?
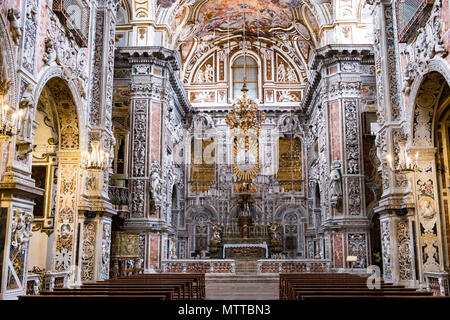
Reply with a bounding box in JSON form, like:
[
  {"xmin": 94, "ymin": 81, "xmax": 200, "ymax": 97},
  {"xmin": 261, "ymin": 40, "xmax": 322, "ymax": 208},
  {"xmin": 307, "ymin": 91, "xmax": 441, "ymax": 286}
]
[{"xmin": 280, "ymin": 273, "xmax": 447, "ymax": 300}]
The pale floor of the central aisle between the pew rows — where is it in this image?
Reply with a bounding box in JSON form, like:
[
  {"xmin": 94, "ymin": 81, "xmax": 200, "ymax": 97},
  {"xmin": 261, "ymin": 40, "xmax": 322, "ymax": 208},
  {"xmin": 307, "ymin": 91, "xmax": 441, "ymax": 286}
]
[{"xmin": 205, "ymin": 273, "xmax": 279, "ymax": 300}]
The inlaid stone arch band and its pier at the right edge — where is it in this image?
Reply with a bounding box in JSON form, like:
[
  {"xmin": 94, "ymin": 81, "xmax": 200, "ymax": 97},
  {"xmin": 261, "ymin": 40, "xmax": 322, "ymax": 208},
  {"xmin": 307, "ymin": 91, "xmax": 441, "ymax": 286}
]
[{"xmin": 407, "ymin": 65, "xmax": 450, "ymax": 281}]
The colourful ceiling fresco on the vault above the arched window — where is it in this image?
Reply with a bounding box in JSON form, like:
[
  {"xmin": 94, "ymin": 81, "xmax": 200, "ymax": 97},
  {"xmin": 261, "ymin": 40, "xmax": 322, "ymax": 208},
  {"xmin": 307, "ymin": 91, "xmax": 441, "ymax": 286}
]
[{"xmin": 196, "ymin": 0, "xmax": 302, "ymax": 36}]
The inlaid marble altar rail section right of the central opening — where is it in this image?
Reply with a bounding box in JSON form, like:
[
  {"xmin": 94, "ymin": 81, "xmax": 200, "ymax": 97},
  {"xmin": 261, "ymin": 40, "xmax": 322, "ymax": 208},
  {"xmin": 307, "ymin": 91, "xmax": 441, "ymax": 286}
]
[{"xmin": 257, "ymin": 259, "xmax": 331, "ymax": 273}]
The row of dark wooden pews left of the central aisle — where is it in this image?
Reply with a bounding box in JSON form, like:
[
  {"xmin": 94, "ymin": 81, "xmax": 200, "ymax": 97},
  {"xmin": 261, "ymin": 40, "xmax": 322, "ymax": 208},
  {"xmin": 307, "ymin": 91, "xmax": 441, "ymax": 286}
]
[{"xmin": 19, "ymin": 273, "xmax": 205, "ymax": 301}]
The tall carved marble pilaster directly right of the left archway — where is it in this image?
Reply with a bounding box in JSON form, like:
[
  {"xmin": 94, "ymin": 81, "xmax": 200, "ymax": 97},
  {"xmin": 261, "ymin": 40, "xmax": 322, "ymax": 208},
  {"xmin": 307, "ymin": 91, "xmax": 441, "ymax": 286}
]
[{"xmin": 77, "ymin": 0, "xmax": 121, "ymax": 281}]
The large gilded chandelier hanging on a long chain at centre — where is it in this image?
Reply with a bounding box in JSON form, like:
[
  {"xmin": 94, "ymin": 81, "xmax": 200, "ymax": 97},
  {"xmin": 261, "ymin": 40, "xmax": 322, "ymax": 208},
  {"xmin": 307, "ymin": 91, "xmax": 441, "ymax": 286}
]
[{"xmin": 225, "ymin": 13, "xmax": 265, "ymax": 133}]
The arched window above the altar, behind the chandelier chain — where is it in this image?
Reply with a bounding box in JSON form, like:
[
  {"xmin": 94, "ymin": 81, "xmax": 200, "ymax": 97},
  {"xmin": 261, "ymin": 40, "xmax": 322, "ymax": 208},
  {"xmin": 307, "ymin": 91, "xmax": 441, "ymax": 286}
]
[{"xmin": 231, "ymin": 56, "xmax": 258, "ymax": 99}]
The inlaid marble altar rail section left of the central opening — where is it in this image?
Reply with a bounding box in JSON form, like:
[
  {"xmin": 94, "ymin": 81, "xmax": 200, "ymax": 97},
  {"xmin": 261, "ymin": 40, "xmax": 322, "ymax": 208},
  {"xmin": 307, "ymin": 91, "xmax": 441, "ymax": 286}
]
[{"xmin": 162, "ymin": 259, "xmax": 235, "ymax": 273}]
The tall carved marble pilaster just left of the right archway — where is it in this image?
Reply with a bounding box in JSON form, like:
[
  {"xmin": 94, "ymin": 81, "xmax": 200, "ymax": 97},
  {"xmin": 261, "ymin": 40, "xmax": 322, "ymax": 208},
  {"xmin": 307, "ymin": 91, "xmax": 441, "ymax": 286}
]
[{"xmin": 372, "ymin": 1, "xmax": 417, "ymax": 286}]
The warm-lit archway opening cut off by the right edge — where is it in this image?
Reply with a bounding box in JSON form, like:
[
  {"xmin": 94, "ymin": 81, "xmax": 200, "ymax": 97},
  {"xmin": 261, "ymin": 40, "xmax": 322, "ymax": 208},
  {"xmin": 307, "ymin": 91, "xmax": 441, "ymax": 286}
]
[{"xmin": 410, "ymin": 71, "xmax": 450, "ymax": 281}]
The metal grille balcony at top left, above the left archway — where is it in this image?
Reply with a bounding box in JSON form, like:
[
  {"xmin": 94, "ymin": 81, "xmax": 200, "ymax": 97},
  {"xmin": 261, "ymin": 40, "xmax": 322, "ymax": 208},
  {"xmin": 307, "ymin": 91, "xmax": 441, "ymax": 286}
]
[{"xmin": 53, "ymin": 0, "xmax": 89, "ymax": 47}]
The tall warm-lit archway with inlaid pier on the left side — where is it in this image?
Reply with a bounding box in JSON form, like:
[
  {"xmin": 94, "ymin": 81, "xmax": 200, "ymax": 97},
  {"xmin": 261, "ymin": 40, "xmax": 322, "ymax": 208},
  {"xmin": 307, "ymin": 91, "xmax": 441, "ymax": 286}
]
[{"xmin": 30, "ymin": 77, "xmax": 81, "ymax": 273}]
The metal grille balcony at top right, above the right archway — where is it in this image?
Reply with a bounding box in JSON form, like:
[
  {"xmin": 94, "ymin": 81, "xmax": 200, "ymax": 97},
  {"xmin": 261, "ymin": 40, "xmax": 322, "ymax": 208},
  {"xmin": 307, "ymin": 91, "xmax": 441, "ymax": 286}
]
[{"xmin": 396, "ymin": 0, "xmax": 434, "ymax": 42}]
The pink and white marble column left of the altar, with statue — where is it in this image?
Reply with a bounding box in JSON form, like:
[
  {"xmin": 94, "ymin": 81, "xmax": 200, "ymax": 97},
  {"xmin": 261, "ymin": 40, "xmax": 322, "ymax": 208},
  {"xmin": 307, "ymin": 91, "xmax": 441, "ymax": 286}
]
[{"xmin": 121, "ymin": 47, "xmax": 188, "ymax": 272}]
